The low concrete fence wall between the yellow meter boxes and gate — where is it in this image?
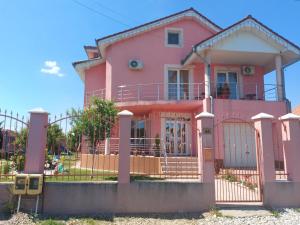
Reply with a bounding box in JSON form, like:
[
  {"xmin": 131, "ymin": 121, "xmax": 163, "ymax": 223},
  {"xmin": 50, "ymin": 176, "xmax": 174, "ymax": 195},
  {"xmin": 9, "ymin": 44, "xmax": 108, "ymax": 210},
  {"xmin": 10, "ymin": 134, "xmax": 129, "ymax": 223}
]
[{"xmin": 43, "ymin": 181, "xmax": 214, "ymax": 215}]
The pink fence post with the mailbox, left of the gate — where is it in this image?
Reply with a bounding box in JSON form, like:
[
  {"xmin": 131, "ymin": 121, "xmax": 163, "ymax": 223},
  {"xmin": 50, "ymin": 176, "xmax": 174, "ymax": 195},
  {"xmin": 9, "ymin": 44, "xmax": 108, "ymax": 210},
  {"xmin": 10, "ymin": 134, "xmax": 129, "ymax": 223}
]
[{"xmin": 195, "ymin": 112, "xmax": 215, "ymax": 183}]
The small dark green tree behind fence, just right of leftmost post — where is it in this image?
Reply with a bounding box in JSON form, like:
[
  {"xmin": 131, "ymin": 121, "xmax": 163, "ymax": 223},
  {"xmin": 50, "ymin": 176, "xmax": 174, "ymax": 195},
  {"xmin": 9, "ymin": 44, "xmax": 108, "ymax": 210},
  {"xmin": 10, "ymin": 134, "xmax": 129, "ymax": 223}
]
[{"xmin": 47, "ymin": 124, "xmax": 66, "ymax": 154}]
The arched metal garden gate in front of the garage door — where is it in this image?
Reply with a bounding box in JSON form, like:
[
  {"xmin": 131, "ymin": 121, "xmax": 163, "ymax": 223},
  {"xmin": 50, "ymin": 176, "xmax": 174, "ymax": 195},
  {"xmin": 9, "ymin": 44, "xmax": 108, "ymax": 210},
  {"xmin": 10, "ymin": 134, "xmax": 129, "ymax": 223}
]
[{"xmin": 215, "ymin": 119, "xmax": 262, "ymax": 202}]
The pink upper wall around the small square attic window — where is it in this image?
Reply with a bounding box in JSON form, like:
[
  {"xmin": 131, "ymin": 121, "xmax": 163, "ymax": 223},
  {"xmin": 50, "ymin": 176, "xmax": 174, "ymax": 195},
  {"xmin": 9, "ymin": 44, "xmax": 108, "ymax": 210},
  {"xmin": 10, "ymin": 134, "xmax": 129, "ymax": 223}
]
[{"xmin": 106, "ymin": 20, "xmax": 212, "ymax": 100}]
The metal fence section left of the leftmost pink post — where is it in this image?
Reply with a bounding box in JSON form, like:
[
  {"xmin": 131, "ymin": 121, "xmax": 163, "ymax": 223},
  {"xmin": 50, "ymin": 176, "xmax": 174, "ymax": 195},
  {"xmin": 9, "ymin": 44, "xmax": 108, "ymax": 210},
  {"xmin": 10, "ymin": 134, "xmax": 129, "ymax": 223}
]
[{"xmin": 0, "ymin": 110, "xmax": 28, "ymax": 181}]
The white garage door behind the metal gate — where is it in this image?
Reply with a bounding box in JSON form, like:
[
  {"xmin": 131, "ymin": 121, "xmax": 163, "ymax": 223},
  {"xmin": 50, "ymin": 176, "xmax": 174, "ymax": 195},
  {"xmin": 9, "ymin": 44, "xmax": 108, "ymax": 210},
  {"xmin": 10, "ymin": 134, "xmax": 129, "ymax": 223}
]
[{"xmin": 223, "ymin": 123, "xmax": 256, "ymax": 169}]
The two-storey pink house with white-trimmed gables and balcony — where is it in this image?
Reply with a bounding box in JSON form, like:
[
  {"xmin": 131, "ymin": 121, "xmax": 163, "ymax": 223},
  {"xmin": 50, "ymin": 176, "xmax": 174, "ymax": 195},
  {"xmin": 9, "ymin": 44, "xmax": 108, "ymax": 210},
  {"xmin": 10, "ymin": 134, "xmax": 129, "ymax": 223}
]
[{"xmin": 73, "ymin": 8, "xmax": 300, "ymax": 170}]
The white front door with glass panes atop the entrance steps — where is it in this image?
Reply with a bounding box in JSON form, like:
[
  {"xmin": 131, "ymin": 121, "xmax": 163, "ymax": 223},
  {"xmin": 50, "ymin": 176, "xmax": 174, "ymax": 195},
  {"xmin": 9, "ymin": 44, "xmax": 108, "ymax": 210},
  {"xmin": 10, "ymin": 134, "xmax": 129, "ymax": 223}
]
[{"xmin": 164, "ymin": 118, "xmax": 190, "ymax": 155}]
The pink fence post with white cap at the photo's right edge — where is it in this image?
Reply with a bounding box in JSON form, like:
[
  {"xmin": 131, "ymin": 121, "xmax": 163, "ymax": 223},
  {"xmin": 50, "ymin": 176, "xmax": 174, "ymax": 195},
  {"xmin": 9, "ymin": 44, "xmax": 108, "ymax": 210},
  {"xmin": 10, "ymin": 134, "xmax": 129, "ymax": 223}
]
[{"xmin": 279, "ymin": 113, "xmax": 300, "ymax": 182}]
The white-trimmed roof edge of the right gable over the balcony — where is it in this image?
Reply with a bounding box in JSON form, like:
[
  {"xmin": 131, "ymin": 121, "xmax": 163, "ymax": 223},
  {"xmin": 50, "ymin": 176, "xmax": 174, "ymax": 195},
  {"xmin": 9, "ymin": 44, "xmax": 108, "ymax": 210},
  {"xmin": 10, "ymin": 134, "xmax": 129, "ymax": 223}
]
[{"xmin": 182, "ymin": 15, "xmax": 300, "ymax": 64}]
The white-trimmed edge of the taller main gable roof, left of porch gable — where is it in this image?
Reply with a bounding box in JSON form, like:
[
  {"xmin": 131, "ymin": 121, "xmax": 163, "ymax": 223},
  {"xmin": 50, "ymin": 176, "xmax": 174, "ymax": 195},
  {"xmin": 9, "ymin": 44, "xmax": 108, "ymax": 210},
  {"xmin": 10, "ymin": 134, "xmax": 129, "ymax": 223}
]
[{"xmin": 96, "ymin": 8, "xmax": 222, "ymax": 56}]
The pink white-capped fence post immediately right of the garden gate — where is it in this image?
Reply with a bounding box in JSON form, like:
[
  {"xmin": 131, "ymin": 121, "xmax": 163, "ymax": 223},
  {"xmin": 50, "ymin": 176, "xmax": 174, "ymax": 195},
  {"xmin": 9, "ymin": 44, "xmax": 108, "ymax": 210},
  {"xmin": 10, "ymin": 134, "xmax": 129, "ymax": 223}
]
[{"xmin": 251, "ymin": 113, "xmax": 275, "ymax": 184}]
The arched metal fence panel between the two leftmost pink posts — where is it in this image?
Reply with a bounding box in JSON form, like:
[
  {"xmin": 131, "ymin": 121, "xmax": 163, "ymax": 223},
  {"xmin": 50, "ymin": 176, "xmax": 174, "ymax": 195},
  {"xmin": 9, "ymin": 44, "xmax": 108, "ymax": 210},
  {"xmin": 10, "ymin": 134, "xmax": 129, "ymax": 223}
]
[{"xmin": 44, "ymin": 114, "xmax": 119, "ymax": 181}]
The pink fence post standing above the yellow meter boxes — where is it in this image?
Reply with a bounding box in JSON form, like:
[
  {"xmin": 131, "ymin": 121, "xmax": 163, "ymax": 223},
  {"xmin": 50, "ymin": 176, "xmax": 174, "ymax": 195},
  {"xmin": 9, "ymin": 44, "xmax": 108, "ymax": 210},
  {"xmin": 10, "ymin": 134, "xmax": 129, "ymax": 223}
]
[{"xmin": 24, "ymin": 108, "xmax": 48, "ymax": 174}]
